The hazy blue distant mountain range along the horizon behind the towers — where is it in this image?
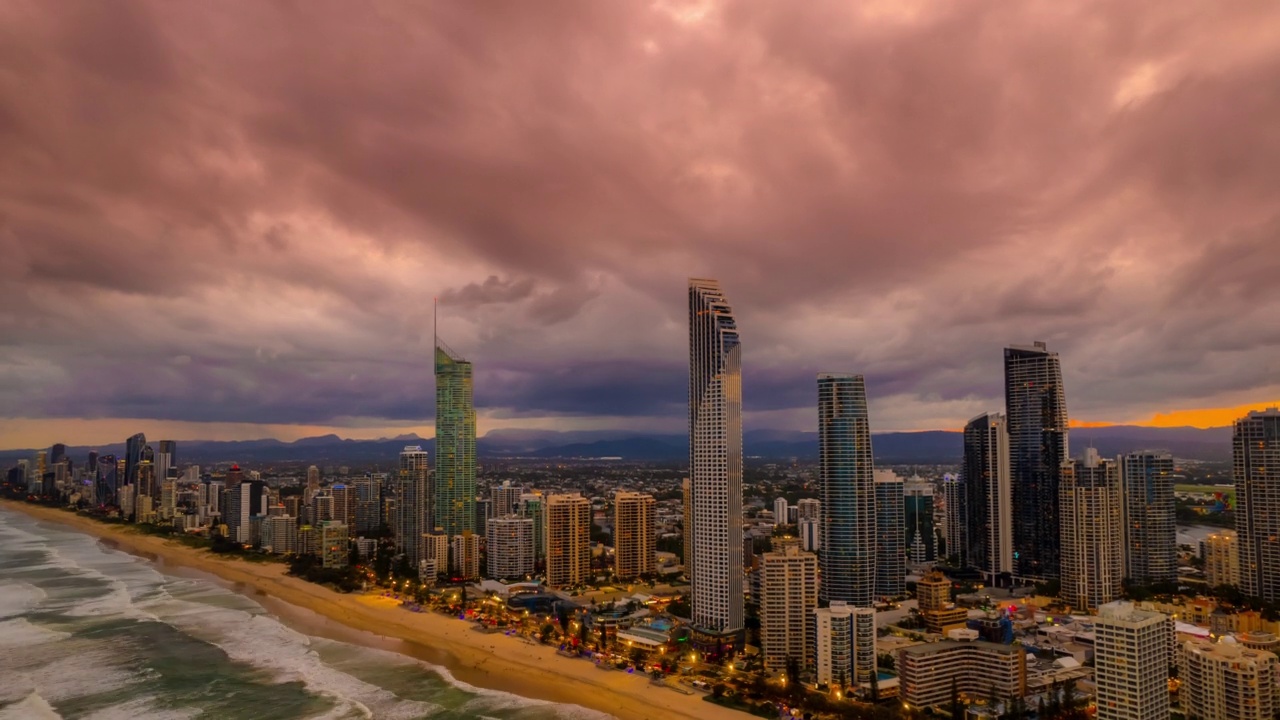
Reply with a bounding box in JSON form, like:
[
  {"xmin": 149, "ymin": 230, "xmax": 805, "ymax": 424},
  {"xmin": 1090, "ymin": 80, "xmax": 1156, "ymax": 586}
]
[{"xmin": 0, "ymin": 425, "xmax": 1231, "ymax": 468}]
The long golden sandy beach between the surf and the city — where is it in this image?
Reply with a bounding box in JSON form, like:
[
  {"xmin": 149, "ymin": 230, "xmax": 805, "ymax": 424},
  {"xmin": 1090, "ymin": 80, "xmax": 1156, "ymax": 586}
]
[{"xmin": 0, "ymin": 501, "xmax": 750, "ymax": 720}]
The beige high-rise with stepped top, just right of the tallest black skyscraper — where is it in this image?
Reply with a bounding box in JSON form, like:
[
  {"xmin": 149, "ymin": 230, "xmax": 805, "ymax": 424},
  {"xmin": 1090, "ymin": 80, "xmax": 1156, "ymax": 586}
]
[{"xmin": 1059, "ymin": 447, "xmax": 1124, "ymax": 610}]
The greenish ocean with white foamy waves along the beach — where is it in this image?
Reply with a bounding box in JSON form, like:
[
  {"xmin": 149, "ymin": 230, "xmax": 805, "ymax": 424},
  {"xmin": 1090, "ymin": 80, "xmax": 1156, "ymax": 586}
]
[{"xmin": 0, "ymin": 510, "xmax": 608, "ymax": 720}]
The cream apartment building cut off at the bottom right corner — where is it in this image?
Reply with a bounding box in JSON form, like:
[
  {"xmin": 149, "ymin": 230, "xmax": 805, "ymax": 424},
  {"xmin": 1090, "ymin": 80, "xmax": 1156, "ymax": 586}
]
[{"xmin": 1178, "ymin": 635, "xmax": 1280, "ymax": 720}]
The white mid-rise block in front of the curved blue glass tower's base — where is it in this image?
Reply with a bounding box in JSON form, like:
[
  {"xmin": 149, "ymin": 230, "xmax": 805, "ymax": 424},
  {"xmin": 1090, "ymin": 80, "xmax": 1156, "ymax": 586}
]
[{"xmin": 809, "ymin": 600, "xmax": 876, "ymax": 688}]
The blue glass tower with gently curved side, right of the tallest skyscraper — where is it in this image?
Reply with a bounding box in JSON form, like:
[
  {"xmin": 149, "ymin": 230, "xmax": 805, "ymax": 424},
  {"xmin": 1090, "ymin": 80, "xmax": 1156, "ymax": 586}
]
[{"xmin": 818, "ymin": 373, "xmax": 876, "ymax": 607}]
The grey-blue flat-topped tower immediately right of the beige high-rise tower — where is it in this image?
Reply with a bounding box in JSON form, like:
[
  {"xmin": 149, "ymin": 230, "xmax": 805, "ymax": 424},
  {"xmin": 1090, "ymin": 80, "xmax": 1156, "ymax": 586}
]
[{"xmin": 1120, "ymin": 450, "xmax": 1178, "ymax": 585}]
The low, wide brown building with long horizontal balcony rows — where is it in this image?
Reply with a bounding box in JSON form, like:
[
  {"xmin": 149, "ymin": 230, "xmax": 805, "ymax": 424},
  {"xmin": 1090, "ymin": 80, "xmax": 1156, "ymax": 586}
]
[{"xmin": 897, "ymin": 641, "xmax": 1027, "ymax": 708}]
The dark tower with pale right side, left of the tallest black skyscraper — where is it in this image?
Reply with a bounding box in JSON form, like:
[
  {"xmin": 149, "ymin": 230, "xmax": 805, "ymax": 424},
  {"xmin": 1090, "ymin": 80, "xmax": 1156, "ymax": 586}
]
[{"xmin": 961, "ymin": 413, "xmax": 1014, "ymax": 583}]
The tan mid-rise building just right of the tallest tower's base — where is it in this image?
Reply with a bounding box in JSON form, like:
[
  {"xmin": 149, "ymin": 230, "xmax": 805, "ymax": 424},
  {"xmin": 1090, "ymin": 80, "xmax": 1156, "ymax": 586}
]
[{"xmin": 760, "ymin": 546, "xmax": 818, "ymax": 673}]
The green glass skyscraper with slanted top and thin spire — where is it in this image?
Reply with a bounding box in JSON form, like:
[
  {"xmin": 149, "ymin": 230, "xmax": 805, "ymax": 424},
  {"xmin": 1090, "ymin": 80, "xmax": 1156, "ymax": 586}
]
[{"xmin": 434, "ymin": 340, "xmax": 476, "ymax": 537}]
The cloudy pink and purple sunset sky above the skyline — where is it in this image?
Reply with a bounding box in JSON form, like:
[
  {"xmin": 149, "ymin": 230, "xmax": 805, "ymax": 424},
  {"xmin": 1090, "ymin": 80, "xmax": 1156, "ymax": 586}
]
[{"xmin": 0, "ymin": 0, "xmax": 1280, "ymax": 447}]
